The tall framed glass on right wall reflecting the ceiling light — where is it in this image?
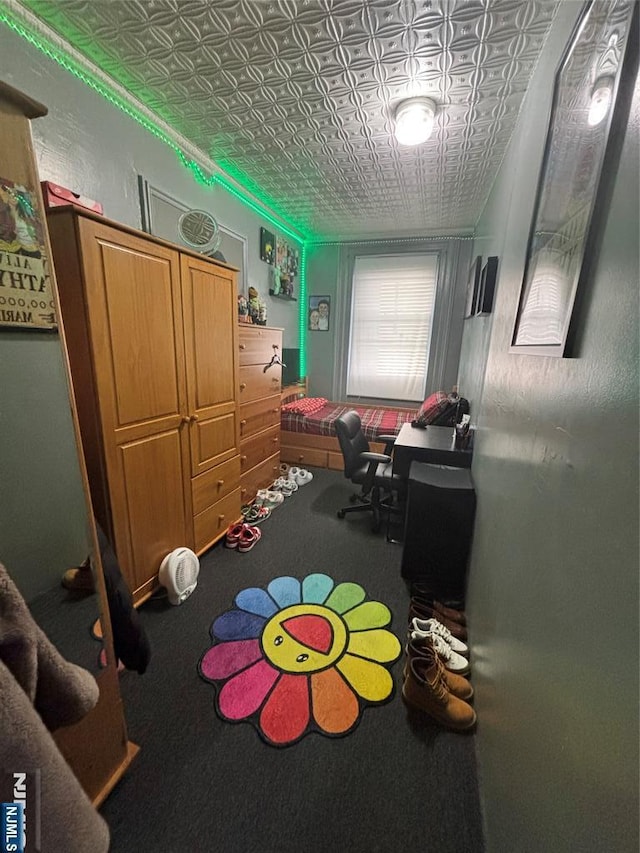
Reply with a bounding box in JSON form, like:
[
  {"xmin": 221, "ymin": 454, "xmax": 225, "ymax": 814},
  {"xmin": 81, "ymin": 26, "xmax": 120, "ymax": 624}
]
[{"xmin": 510, "ymin": 0, "xmax": 638, "ymax": 356}]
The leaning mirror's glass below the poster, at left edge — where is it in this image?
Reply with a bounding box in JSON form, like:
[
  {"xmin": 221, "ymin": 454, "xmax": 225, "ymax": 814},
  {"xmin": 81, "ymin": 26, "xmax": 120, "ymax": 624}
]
[{"xmin": 0, "ymin": 328, "xmax": 102, "ymax": 674}]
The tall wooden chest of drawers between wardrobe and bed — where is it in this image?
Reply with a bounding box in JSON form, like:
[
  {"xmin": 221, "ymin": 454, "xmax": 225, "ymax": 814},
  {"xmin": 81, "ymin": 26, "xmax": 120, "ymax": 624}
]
[{"xmin": 238, "ymin": 323, "xmax": 282, "ymax": 504}]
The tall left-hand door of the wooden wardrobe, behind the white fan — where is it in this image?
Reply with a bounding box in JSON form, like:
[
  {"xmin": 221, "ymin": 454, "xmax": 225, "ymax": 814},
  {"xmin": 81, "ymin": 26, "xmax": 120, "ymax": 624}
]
[{"xmin": 79, "ymin": 219, "xmax": 193, "ymax": 601}]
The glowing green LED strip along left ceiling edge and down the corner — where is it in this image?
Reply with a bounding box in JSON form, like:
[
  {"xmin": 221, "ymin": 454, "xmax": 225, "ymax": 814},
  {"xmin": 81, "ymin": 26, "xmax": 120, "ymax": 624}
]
[{"xmin": 0, "ymin": 8, "xmax": 309, "ymax": 364}]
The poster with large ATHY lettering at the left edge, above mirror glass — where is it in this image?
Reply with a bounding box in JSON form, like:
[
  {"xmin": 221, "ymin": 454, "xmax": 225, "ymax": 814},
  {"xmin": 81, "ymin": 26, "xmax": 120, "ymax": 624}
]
[{"xmin": 0, "ymin": 178, "xmax": 57, "ymax": 329}]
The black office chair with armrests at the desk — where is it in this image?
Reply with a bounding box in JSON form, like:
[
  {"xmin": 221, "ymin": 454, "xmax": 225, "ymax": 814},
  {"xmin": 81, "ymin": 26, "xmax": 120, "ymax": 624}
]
[{"xmin": 334, "ymin": 410, "xmax": 402, "ymax": 532}]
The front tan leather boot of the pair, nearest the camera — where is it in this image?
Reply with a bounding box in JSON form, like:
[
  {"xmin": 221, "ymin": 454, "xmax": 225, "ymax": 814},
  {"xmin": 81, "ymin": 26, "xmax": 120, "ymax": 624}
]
[{"xmin": 402, "ymin": 656, "xmax": 476, "ymax": 732}]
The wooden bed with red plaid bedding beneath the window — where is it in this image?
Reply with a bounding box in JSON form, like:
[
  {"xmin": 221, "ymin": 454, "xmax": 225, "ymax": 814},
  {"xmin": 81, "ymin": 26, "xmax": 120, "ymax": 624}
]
[{"xmin": 280, "ymin": 383, "xmax": 462, "ymax": 471}]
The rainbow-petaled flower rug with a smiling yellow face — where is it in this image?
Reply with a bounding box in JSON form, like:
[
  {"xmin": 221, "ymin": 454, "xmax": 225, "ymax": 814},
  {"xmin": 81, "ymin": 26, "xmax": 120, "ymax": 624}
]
[{"xmin": 198, "ymin": 574, "xmax": 401, "ymax": 746}]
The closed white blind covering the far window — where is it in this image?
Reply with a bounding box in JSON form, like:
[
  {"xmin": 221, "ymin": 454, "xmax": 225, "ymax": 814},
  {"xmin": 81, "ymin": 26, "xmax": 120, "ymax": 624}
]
[{"xmin": 347, "ymin": 254, "xmax": 438, "ymax": 402}]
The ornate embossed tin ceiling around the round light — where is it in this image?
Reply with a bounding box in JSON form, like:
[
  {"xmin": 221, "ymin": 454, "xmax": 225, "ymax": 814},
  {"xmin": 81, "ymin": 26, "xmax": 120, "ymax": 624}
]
[{"xmin": 13, "ymin": 0, "xmax": 557, "ymax": 239}]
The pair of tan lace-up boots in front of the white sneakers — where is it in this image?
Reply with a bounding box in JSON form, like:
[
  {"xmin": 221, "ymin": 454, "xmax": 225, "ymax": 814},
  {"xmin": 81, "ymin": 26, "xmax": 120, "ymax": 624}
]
[{"xmin": 402, "ymin": 639, "xmax": 476, "ymax": 732}]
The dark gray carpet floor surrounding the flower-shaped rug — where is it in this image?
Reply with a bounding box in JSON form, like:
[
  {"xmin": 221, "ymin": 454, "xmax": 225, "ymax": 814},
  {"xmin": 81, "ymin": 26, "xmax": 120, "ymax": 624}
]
[{"xmin": 102, "ymin": 469, "xmax": 483, "ymax": 853}]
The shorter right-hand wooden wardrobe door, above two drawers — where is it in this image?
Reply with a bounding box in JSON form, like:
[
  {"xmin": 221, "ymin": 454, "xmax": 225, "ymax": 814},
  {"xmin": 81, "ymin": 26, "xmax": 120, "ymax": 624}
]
[{"xmin": 181, "ymin": 255, "xmax": 240, "ymax": 477}]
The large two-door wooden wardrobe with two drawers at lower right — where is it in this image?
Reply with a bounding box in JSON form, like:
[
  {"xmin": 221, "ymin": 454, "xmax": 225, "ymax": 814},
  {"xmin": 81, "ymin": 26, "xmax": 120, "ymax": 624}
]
[{"xmin": 48, "ymin": 207, "xmax": 240, "ymax": 603}]
